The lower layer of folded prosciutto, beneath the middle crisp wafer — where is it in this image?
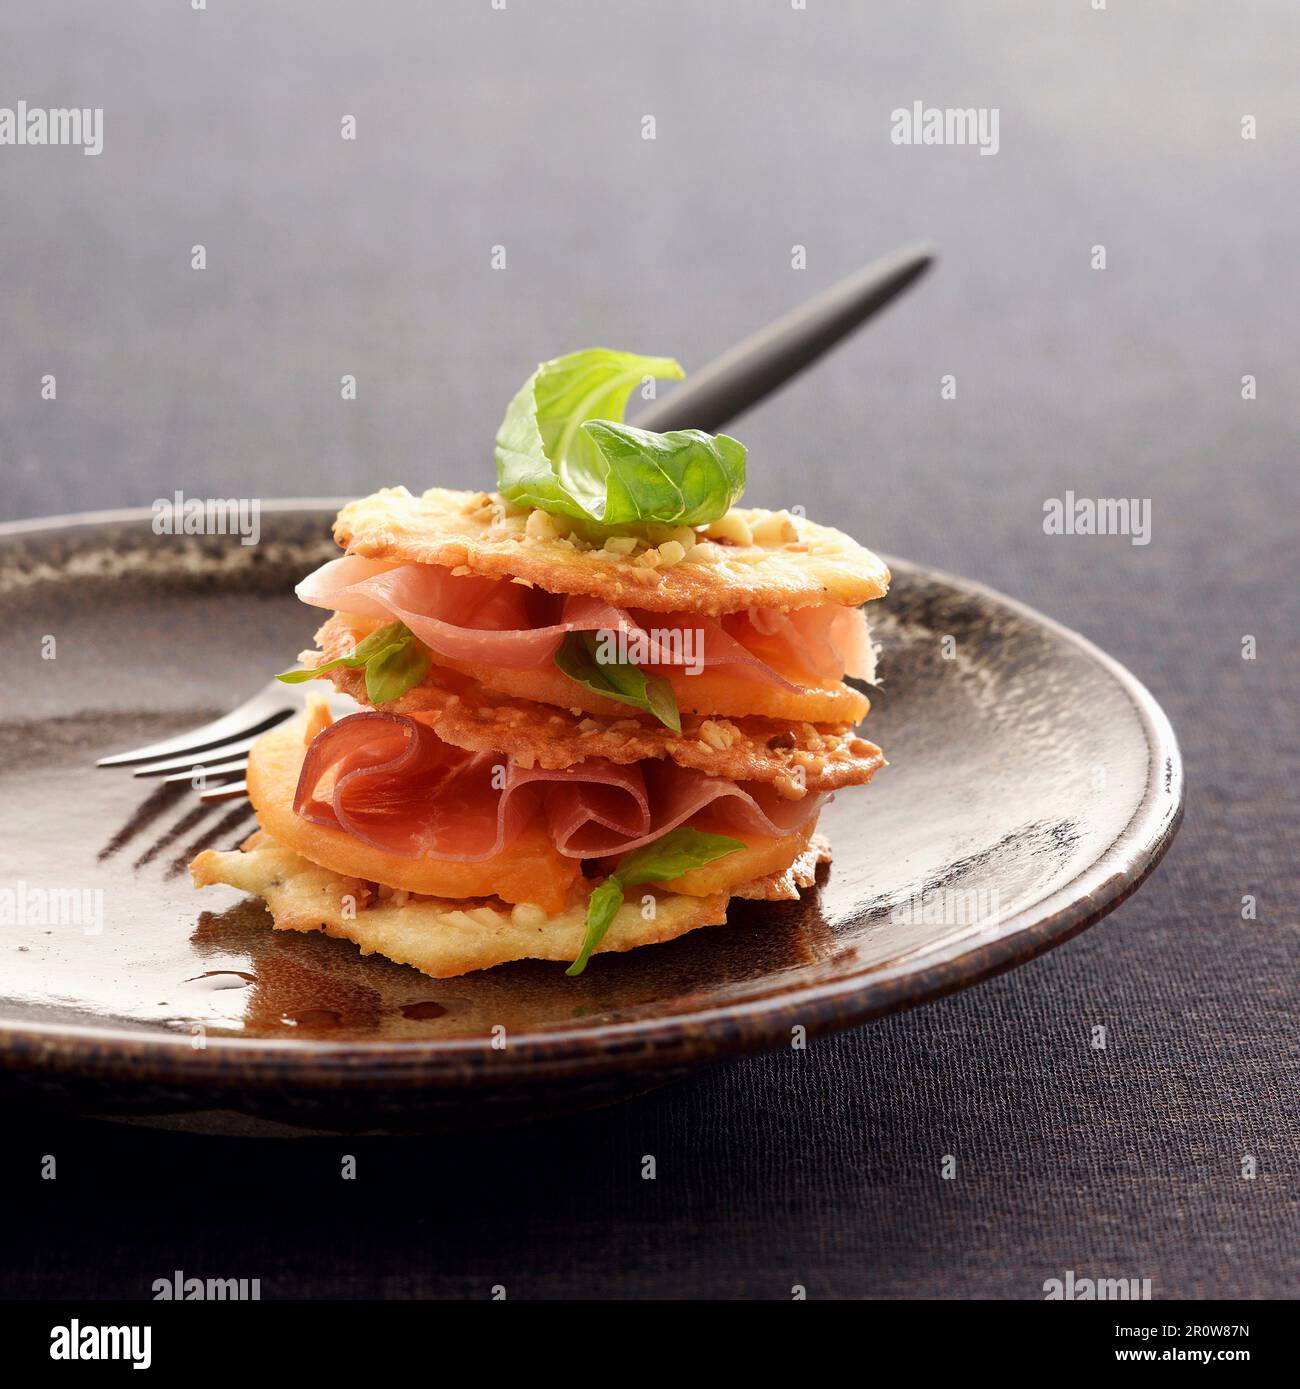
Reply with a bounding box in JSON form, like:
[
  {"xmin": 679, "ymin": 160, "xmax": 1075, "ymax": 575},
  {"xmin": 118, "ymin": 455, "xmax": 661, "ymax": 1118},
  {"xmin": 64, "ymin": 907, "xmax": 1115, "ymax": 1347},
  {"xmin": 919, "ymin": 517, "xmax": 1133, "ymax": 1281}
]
[{"xmin": 293, "ymin": 710, "xmax": 828, "ymax": 863}]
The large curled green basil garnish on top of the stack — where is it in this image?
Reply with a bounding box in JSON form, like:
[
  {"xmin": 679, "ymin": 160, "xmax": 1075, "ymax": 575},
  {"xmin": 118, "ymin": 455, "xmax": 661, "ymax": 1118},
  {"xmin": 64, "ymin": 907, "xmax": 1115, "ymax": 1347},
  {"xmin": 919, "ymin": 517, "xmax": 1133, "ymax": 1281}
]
[{"xmin": 496, "ymin": 347, "xmax": 746, "ymax": 538}]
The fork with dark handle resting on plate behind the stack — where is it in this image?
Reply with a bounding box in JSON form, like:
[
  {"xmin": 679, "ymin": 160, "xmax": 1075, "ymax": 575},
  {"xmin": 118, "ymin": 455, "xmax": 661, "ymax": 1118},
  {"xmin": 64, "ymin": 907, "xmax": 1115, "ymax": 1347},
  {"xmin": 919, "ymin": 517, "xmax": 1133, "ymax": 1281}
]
[{"xmin": 96, "ymin": 243, "xmax": 935, "ymax": 800}]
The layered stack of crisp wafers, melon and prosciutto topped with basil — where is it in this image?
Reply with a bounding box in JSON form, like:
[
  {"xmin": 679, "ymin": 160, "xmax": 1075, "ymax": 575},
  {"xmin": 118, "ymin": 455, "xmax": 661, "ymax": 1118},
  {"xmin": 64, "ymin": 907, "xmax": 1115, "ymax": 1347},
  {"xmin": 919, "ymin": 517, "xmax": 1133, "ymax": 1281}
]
[{"xmin": 192, "ymin": 353, "xmax": 889, "ymax": 978}]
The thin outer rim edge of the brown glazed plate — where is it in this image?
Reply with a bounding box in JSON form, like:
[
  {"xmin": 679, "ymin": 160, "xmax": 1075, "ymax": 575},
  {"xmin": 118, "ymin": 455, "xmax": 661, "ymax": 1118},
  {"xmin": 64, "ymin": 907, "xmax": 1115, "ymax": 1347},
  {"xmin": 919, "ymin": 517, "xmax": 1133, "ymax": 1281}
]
[{"xmin": 0, "ymin": 497, "xmax": 1186, "ymax": 1092}]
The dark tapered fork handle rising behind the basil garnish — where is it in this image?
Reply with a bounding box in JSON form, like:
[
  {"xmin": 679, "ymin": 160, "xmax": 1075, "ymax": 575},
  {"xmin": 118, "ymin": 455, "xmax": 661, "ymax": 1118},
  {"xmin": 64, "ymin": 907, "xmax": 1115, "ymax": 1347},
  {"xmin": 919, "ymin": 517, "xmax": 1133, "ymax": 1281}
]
[{"xmin": 632, "ymin": 243, "xmax": 935, "ymax": 433}]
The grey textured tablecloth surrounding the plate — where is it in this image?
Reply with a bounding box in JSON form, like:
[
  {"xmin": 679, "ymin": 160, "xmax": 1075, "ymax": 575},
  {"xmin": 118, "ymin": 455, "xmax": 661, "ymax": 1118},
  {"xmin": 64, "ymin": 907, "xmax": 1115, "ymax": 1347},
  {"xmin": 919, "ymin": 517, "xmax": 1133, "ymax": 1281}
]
[{"xmin": 0, "ymin": 0, "xmax": 1300, "ymax": 1297}]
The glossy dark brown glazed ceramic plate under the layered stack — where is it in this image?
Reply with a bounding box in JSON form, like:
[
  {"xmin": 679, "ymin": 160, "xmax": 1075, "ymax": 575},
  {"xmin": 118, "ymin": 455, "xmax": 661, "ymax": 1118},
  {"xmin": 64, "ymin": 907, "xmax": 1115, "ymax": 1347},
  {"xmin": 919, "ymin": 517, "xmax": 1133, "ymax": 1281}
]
[{"xmin": 0, "ymin": 501, "xmax": 1182, "ymax": 1128}]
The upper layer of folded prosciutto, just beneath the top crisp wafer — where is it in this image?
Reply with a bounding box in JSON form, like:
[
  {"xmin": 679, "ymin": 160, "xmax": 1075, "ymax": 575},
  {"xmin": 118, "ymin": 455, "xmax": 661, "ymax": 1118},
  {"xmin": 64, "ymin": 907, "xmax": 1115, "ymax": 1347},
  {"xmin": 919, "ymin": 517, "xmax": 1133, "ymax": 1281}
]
[{"xmin": 296, "ymin": 556, "xmax": 871, "ymax": 690}]
